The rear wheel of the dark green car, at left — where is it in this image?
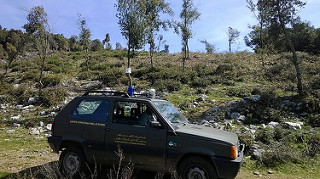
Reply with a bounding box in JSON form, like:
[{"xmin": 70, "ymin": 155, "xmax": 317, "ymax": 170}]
[{"xmin": 59, "ymin": 147, "xmax": 87, "ymax": 178}]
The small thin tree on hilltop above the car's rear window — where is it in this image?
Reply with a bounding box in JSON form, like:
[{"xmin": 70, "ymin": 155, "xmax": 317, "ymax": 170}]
[{"xmin": 78, "ymin": 14, "xmax": 91, "ymax": 71}]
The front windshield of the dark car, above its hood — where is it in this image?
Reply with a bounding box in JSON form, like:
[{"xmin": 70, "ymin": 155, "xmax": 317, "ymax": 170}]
[{"xmin": 152, "ymin": 101, "xmax": 188, "ymax": 124}]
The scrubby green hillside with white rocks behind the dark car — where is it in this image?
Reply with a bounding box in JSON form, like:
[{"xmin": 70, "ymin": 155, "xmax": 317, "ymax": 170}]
[{"xmin": 0, "ymin": 50, "xmax": 320, "ymax": 178}]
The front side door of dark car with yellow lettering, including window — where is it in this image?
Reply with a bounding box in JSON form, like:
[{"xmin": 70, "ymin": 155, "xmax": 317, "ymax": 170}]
[{"xmin": 106, "ymin": 101, "xmax": 167, "ymax": 168}]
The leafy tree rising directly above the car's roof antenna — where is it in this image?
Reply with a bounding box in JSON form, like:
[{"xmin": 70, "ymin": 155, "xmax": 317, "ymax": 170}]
[{"xmin": 115, "ymin": 0, "xmax": 146, "ymax": 86}]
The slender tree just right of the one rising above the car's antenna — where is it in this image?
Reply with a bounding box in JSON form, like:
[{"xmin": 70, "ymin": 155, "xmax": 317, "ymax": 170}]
[{"xmin": 144, "ymin": 0, "xmax": 173, "ymax": 68}]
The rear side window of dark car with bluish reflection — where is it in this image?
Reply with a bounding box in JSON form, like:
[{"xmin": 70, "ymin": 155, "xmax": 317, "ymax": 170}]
[{"xmin": 71, "ymin": 99, "xmax": 110, "ymax": 122}]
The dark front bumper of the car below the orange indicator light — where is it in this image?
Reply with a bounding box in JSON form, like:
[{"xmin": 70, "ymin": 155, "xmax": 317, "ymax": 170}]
[{"xmin": 211, "ymin": 146, "xmax": 244, "ymax": 178}]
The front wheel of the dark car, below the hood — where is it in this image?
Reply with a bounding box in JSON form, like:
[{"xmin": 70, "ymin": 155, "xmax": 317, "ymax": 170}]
[{"xmin": 178, "ymin": 157, "xmax": 217, "ymax": 179}]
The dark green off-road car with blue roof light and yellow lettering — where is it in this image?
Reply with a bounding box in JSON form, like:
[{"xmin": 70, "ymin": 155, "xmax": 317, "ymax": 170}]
[{"xmin": 48, "ymin": 91, "xmax": 244, "ymax": 179}]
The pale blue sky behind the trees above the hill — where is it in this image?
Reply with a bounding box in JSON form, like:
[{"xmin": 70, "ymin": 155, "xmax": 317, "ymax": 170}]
[{"xmin": 0, "ymin": 0, "xmax": 320, "ymax": 53}]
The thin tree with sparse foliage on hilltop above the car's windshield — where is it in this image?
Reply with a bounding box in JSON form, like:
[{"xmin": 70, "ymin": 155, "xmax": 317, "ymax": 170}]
[{"xmin": 175, "ymin": 0, "xmax": 200, "ymax": 69}]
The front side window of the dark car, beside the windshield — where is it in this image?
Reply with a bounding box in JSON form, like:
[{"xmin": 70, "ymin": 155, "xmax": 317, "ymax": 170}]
[{"xmin": 112, "ymin": 101, "xmax": 156, "ymax": 126}]
